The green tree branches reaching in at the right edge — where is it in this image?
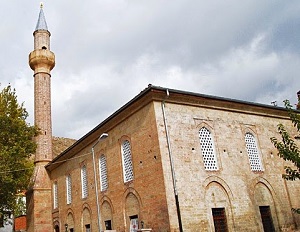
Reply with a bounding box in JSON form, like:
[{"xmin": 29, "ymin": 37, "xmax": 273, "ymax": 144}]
[{"xmin": 271, "ymin": 100, "xmax": 300, "ymax": 214}]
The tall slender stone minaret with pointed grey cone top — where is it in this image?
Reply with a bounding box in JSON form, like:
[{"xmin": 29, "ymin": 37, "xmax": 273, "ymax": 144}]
[{"xmin": 27, "ymin": 4, "xmax": 55, "ymax": 232}]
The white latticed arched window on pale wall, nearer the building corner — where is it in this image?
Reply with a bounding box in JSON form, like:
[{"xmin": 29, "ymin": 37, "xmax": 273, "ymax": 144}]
[{"xmin": 199, "ymin": 127, "xmax": 218, "ymax": 170}]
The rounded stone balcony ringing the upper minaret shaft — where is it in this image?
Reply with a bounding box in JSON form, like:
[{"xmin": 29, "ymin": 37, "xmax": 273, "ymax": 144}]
[{"xmin": 29, "ymin": 49, "xmax": 55, "ymax": 74}]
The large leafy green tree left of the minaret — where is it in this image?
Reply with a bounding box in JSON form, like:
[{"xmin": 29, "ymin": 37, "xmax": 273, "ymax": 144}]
[{"xmin": 0, "ymin": 85, "xmax": 39, "ymax": 222}]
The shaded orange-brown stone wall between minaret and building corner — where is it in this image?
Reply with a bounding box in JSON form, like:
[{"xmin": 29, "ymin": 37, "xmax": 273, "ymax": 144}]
[{"xmin": 51, "ymin": 104, "xmax": 169, "ymax": 231}]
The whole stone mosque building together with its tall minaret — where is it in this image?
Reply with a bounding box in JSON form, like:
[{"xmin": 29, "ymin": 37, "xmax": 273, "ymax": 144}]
[{"xmin": 26, "ymin": 4, "xmax": 300, "ymax": 232}]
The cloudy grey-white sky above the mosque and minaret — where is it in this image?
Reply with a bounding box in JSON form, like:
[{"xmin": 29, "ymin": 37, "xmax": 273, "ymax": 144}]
[{"xmin": 0, "ymin": 0, "xmax": 300, "ymax": 139}]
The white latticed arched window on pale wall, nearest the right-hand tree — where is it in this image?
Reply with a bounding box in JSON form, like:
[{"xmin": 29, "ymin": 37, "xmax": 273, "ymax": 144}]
[{"xmin": 245, "ymin": 133, "xmax": 262, "ymax": 171}]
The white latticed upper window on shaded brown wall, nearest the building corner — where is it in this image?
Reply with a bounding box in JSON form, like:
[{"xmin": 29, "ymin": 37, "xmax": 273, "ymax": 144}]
[{"xmin": 122, "ymin": 140, "xmax": 133, "ymax": 183}]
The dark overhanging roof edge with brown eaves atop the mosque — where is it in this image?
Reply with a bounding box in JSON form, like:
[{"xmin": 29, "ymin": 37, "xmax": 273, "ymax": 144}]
[{"xmin": 46, "ymin": 84, "xmax": 288, "ymax": 170}]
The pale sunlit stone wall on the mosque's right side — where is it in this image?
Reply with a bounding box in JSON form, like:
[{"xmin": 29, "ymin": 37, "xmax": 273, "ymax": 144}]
[{"xmin": 155, "ymin": 100, "xmax": 300, "ymax": 231}]
